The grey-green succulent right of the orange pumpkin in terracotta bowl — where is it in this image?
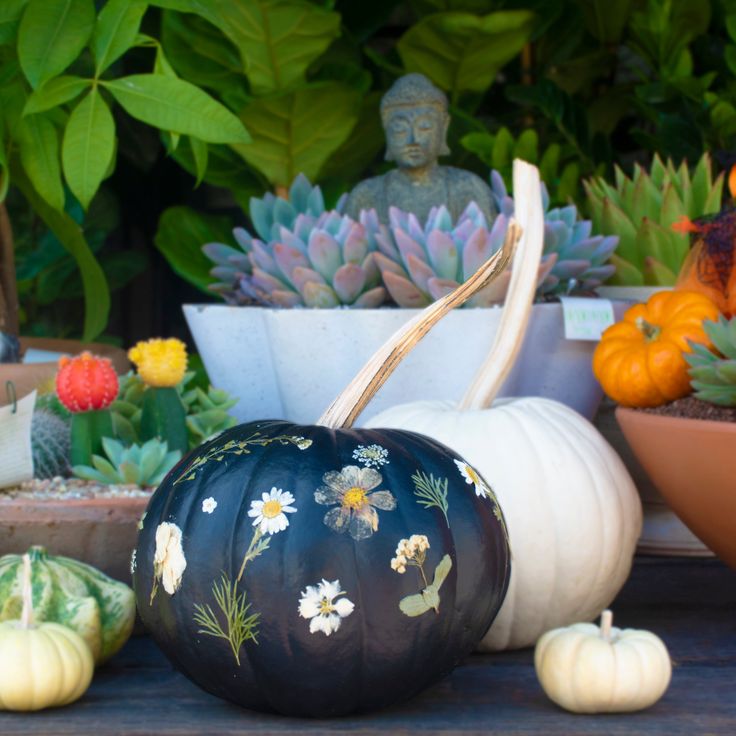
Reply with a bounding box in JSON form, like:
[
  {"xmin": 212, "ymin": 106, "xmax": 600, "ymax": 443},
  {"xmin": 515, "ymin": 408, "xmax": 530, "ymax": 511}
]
[{"xmin": 685, "ymin": 316, "xmax": 736, "ymax": 406}]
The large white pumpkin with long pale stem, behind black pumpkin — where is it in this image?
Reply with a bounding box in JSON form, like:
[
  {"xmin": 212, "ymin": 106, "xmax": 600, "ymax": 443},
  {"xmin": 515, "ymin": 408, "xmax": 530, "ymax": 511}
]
[{"xmin": 367, "ymin": 166, "xmax": 642, "ymax": 651}]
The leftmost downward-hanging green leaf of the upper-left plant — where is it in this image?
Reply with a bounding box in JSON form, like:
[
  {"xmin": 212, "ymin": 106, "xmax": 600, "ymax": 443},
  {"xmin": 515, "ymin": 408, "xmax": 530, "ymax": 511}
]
[{"xmin": 18, "ymin": 115, "xmax": 64, "ymax": 210}]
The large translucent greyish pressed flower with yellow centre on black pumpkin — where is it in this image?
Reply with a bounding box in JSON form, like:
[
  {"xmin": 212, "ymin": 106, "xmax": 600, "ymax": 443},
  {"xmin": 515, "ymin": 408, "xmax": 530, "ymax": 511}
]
[{"xmin": 314, "ymin": 465, "xmax": 396, "ymax": 541}]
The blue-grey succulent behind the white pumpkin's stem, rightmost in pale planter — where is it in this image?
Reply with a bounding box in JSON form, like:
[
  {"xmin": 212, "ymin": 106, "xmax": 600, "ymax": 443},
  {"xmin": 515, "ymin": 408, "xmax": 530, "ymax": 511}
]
[{"xmin": 491, "ymin": 171, "xmax": 619, "ymax": 298}]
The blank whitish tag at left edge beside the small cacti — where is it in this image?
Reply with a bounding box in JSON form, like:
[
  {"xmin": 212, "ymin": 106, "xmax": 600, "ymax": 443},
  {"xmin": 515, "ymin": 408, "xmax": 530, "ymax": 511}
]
[{"xmin": 0, "ymin": 391, "xmax": 36, "ymax": 488}]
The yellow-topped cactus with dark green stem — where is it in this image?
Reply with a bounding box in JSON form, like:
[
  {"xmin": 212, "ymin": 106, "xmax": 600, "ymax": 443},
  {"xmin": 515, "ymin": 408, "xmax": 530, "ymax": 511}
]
[{"xmin": 128, "ymin": 337, "xmax": 189, "ymax": 455}]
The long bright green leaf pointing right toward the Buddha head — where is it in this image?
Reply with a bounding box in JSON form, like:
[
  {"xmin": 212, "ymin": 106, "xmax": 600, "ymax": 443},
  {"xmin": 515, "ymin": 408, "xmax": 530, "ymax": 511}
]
[{"xmin": 101, "ymin": 74, "xmax": 250, "ymax": 143}]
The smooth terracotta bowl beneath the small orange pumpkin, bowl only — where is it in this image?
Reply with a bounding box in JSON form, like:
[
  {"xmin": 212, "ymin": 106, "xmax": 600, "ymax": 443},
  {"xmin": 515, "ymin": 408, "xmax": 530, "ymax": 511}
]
[{"xmin": 616, "ymin": 407, "xmax": 736, "ymax": 569}]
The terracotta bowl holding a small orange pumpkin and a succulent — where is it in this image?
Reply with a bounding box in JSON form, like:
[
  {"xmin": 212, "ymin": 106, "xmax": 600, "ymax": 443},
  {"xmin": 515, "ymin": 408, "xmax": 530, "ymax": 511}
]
[{"xmin": 593, "ymin": 264, "xmax": 736, "ymax": 566}]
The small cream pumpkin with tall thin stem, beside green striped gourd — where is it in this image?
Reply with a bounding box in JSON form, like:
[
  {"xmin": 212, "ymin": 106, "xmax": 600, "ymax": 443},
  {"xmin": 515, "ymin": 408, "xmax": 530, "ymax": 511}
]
[{"xmin": 0, "ymin": 554, "xmax": 94, "ymax": 711}]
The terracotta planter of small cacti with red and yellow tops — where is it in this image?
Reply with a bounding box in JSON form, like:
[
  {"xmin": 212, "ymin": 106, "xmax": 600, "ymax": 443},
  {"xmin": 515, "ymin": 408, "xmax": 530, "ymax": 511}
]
[{"xmin": 0, "ymin": 339, "xmax": 236, "ymax": 580}]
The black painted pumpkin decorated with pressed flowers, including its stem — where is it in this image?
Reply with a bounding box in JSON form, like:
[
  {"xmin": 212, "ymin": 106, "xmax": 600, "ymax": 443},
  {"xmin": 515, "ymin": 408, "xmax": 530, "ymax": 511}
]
[{"xmin": 133, "ymin": 211, "xmax": 518, "ymax": 716}]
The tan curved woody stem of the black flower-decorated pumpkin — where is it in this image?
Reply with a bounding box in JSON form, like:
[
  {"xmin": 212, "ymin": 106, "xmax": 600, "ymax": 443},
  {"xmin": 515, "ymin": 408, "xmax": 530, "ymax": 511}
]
[{"xmin": 317, "ymin": 210, "xmax": 533, "ymax": 429}]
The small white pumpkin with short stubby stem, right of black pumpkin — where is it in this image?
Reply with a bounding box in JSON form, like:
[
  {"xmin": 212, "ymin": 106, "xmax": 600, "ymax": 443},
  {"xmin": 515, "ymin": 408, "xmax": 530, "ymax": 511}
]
[{"xmin": 534, "ymin": 611, "xmax": 672, "ymax": 713}]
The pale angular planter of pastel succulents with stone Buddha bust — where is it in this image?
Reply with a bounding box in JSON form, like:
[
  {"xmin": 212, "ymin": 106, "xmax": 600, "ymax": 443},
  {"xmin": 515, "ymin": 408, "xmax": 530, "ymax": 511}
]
[{"xmin": 184, "ymin": 75, "xmax": 617, "ymax": 421}]
